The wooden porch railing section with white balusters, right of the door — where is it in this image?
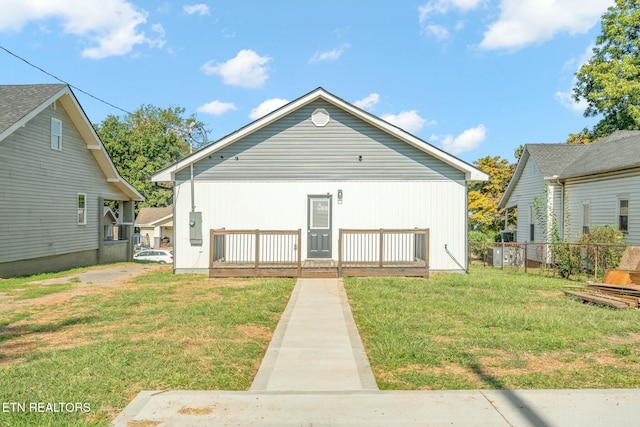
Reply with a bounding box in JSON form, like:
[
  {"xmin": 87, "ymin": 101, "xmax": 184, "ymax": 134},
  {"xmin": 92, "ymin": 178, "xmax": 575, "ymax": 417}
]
[{"xmin": 338, "ymin": 228, "xmax": 429, "ymax": 275}]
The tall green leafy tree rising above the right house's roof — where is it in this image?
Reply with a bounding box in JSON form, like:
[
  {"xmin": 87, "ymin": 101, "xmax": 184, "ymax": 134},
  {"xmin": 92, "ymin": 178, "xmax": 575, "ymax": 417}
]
[{"xmin": 573, "ymin": 0, "xmax": 640, "ymax": 139}]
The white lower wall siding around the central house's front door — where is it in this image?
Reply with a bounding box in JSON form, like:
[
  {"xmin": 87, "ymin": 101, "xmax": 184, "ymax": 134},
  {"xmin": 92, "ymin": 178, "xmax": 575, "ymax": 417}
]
[{"xmin": 174, "ymin": 181, "xmax": 467, "ymax": 272}]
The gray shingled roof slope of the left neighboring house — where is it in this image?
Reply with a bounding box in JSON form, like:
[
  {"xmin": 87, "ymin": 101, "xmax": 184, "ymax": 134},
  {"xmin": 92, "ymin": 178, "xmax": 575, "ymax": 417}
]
[{"xmin": 0, "ymin": 84, "xmax": 67, "ymax": 134}]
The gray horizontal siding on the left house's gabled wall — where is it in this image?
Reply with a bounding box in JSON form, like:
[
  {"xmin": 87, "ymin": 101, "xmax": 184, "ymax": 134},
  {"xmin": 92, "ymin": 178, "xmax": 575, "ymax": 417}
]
[{"xmin": 0, "ymin": 104, "xmax": 126, "ymax": 263}]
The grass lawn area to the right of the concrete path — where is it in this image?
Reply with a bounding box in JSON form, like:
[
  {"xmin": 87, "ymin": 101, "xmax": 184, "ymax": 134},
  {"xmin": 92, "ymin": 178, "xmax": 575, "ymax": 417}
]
[{"xmin": 345, "ymin": 266, "xmax": 640, "ymax": 390}]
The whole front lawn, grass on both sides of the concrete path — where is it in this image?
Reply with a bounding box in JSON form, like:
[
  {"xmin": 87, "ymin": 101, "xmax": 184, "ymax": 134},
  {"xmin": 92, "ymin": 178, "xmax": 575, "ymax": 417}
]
[{"xmin": 0, "ymin": 267, "xmax": 640, "ymax": 426}]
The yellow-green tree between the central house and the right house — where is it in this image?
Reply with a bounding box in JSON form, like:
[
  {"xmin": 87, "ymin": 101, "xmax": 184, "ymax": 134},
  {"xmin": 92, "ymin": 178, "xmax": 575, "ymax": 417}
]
[{"xmin": 469, "ymin": 156, "xmax": 515, "ymax": 236}]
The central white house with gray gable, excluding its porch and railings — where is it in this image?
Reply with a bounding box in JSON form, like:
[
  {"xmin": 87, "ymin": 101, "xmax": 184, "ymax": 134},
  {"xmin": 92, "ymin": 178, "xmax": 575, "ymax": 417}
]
[{"xmin": 152, "ymin": 88, "xmax": 488, "ymax": 273}]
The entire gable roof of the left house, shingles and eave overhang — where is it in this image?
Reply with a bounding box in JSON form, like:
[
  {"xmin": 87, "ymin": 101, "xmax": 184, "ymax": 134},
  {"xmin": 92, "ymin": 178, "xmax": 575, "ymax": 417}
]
[{"xmin": 0, "ymin": 84, "xmax": 144, "ymax": 201}]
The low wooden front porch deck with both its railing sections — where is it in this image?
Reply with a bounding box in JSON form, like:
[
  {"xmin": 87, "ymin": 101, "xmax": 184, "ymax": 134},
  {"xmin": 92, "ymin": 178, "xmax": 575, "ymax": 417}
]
[{"xmin": 209, "ymin": 228, "xmax": 429, "ymax": 277}]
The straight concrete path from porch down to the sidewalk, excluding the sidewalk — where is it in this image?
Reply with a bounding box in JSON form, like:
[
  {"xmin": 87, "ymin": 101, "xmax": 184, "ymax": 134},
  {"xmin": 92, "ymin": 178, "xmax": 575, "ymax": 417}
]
[{"xmin": 251, "ymin": 279, "xmax": 378, "ymax": 391}]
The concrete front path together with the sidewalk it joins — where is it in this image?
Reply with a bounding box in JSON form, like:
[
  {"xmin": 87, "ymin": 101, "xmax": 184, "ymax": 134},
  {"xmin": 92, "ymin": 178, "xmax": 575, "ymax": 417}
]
[{"xmin": 113, "ymin": 279, "xmax": 640, "ymax": 427}]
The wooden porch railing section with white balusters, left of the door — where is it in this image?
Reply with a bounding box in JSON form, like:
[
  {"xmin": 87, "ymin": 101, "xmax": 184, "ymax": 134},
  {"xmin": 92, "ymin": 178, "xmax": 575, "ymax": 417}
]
[{"xmin": 209, "ymin": 229, "xmax": 302, "ymax": 275}]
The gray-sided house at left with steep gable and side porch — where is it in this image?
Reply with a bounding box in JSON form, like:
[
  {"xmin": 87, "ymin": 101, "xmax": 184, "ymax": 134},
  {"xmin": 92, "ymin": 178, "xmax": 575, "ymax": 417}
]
[{"xmin": 0, "ymin": 84, "xmax": 144, "ymax": 277}]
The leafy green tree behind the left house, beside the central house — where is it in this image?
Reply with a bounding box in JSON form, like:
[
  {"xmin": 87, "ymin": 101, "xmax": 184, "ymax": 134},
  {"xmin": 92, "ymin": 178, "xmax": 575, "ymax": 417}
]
[{"xmin": 95, "ymin": 105, "xmax": 202, "ymax": 207}]
